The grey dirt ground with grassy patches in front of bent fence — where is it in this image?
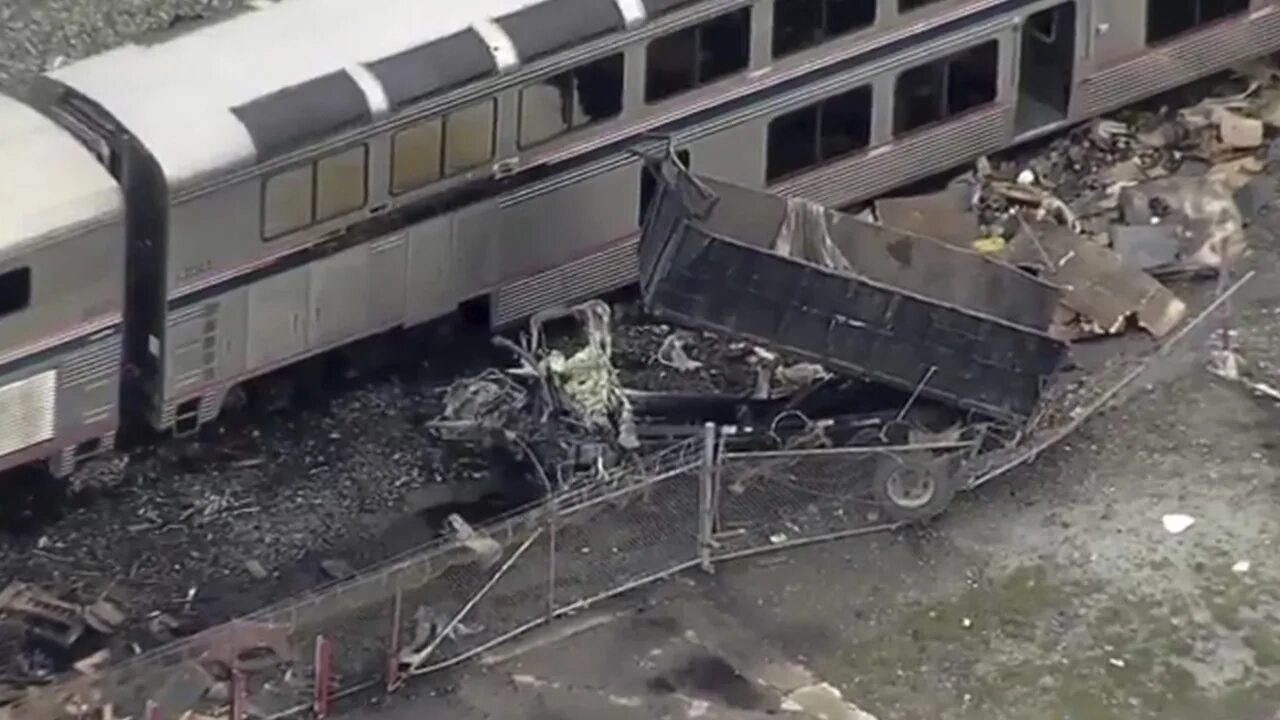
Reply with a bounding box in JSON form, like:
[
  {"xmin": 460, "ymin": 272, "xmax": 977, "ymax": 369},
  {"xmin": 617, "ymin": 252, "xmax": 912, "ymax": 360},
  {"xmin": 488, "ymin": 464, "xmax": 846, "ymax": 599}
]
[{"xmin": 335, "ymin": 233, "xmax": 1280, "ymax": 720}]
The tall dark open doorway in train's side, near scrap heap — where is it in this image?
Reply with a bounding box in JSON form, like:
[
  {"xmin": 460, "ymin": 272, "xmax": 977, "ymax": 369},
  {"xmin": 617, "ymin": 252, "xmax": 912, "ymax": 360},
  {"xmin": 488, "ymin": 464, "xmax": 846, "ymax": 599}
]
[{"xmin": 1018, "ymin": 0, "xmax": 1075, "ymax": 135}]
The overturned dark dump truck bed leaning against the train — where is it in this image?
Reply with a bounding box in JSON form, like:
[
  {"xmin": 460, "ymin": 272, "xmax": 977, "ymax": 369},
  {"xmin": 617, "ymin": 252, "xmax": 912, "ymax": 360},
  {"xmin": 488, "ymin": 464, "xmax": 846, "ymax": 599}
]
[{"xmin": 640, "ymin": 160, "xmax": 1066, "ymax": 424}]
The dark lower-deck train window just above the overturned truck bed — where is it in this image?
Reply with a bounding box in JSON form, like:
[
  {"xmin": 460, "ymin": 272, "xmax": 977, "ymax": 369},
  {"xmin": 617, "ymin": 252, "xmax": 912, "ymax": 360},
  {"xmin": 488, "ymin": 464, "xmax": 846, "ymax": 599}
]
[{"xmin": 764, "ymin": 86, "xmax": 872, "ymax": 182}]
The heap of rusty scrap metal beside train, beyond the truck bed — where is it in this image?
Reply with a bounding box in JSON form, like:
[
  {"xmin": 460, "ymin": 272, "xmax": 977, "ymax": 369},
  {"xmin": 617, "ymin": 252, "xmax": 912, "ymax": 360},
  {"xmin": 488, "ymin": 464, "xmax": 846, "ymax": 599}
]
[{"xmin": 870, "ymin": 69, "xmax": 1280, "ymax": 340}]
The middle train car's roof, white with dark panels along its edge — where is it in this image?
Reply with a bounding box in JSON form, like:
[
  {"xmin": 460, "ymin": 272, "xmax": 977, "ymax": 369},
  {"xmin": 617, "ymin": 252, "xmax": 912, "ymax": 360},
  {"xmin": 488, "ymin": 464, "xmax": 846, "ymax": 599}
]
[{"xmin": 49, "ymin": 0, "xmax": 650, "ymax": 191}]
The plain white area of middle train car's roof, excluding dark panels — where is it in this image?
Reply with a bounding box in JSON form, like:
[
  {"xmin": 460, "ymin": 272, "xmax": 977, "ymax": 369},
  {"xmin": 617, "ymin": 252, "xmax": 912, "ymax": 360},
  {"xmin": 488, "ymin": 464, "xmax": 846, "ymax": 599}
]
[{"xmin": 50, "ymin": 0, "xmax": 538, "ymax": 190}]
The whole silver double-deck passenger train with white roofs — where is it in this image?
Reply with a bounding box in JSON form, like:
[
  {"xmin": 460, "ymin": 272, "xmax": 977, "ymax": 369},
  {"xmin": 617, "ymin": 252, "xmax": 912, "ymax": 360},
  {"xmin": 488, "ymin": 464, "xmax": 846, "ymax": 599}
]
[{"xmin": 0, "ymin": 0, "xmax": 1280, "ymax": 474}]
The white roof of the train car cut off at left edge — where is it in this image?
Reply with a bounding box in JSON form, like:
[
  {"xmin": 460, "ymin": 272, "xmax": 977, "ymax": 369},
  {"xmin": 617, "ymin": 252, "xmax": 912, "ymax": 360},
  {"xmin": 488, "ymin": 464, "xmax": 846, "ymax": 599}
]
[{"xmin": 0, "ymin": 95, "xmax": 123, "ymax": 255}]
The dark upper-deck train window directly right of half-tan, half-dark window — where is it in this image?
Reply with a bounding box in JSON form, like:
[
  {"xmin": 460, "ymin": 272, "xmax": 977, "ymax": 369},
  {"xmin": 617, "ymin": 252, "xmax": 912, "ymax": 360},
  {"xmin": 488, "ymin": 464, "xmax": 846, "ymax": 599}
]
[{"xmin": 644, "ymin": 8, "xmax": 751, "ymax": 102}]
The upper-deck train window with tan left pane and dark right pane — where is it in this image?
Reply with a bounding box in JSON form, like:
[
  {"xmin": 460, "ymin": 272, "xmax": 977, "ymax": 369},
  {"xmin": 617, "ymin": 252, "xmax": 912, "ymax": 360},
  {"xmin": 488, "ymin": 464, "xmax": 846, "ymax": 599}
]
[{"xmin": 520, "ymin": 53, "xmax": 625, "ymax": 147}]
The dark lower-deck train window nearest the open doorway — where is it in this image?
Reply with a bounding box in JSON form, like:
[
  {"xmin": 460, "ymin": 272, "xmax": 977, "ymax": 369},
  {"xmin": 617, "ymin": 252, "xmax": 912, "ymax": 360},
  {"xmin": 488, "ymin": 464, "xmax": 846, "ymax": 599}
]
[{"xmin": 893, "ymin": 40, "xmax": 1000, "ymax": 133}]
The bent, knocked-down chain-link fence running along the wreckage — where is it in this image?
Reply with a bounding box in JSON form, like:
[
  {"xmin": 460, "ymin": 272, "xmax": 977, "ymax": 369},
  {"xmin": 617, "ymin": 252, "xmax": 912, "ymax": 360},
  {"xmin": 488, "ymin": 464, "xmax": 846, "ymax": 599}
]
[{"xmin": 0, "ymin": 281, "xmax": 1243, "ymax": 720}]
